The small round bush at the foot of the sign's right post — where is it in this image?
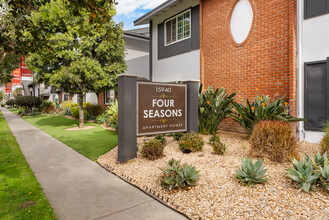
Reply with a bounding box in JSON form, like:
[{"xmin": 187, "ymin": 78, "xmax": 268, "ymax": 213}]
[{"xmin": 178, "ymin": 132, "xmax": 204, "ymax": 153}]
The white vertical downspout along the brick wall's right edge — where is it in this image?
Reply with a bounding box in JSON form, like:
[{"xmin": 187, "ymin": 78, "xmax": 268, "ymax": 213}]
[{"xmin": 297, "ymin": 0, "xmax": 305, "ymax": 140}]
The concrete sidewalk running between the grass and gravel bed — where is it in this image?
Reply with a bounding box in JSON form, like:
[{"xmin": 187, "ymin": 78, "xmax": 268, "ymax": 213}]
[{"xmin": 0, "ymin": 108, "xmax": 186, "ymax": 220}]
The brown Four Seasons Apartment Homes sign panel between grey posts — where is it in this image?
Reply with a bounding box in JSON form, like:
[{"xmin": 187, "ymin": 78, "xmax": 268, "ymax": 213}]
[{"xmin": 137, "ymin": 82, "xmax": 187, "ymax": 136}]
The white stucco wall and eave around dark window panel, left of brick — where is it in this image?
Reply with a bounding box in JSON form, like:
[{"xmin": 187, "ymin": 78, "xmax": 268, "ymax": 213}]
[{"xmin": 152, "ymin": 0, "xmax": 200, "ymax": 82}]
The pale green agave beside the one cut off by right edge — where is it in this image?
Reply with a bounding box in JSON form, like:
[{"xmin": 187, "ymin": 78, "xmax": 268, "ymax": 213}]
[{"xmin": 287, "ymin": 158, "xmax": 321, "ymax": 192}]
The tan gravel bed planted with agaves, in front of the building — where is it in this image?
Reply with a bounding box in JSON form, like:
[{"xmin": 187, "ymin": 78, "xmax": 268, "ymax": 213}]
[{"xmin": 98, "ymin": 132, "xmax": 329, "ymax": 220}]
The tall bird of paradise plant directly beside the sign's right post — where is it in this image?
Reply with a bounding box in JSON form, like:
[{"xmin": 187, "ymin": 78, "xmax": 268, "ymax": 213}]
[{"xmin": 198, "ymin": 84, "xmax": 236, "ymax": 134}]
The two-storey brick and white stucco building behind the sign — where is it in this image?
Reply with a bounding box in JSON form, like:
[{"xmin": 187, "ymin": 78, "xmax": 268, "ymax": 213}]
[{"xmin": 135, "ymin": 0, "xmax": 329, "ymax": 142}]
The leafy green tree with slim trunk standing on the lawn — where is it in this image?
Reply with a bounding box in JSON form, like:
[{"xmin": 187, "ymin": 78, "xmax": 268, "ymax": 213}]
[{"xmin": 26, "ymin": 0, "xmax": 126, "ymax": 128}]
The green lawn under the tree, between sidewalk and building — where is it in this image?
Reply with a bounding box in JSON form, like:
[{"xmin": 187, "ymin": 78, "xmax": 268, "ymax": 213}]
[{"xmin": 23, "ymin": 115, "xmax": 118, "ymax": 161}]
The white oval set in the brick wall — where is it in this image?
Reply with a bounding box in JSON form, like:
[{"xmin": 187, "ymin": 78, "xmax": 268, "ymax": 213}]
[{"xmin": 230, "ymin": 0, "xmax": 254, "ymax": 44}]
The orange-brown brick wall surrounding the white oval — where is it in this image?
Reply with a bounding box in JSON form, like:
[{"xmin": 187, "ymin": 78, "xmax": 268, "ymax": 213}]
[{"xmin": 200, "ymin": 0, "xmax": 297, "ymax": 131}]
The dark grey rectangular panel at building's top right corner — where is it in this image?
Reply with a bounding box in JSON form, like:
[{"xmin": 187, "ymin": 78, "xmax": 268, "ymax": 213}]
[{"xmin": 304, "ymin": 0, "xmax": 329, "ymax": 18}]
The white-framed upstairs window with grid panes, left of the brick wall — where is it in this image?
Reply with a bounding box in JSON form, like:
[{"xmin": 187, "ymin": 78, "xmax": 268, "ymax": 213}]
[{"xmin": 165, "ymin": 10, "xmax": 191, "ymax": 45}]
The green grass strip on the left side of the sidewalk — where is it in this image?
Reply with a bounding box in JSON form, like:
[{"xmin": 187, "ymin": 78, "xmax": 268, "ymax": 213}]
[{"xmin": 0, "ymin": 111, "xmax": 56, "ymax": 220}]
